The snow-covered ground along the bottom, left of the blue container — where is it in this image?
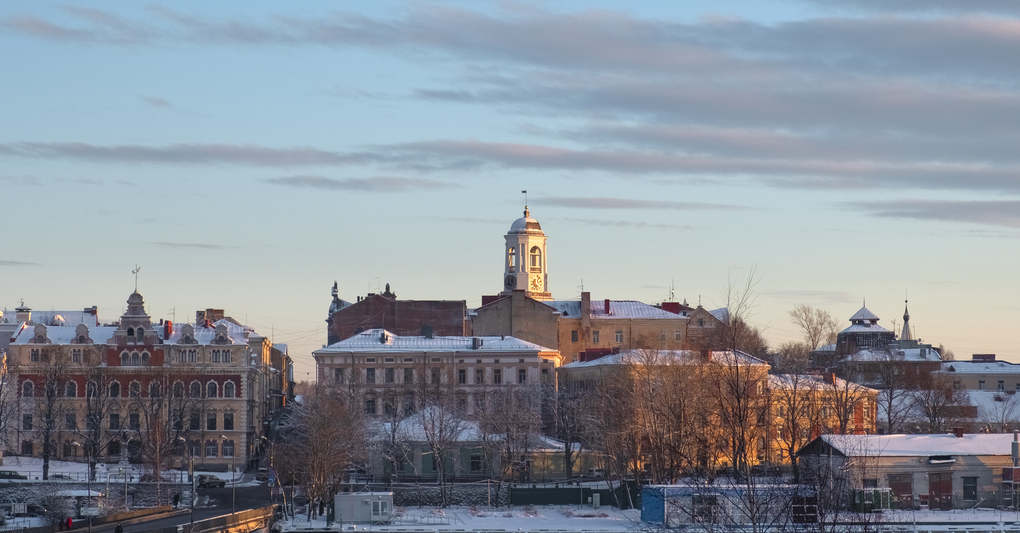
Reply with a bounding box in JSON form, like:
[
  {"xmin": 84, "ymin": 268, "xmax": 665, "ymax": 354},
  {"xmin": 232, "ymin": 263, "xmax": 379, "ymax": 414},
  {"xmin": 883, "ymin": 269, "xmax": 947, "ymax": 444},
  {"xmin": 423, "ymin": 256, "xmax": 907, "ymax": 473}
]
[{"xmin": 284, "ymin": 505, "xmax": 641, "ymax": 532}]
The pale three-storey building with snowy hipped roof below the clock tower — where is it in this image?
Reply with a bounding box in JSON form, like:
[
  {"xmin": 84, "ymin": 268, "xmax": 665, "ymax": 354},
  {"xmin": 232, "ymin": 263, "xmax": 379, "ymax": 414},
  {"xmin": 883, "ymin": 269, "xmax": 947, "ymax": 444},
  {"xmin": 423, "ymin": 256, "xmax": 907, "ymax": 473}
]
[{"xmin": 312, "ymin": 329, "xmax": 561, "ymax": 416}]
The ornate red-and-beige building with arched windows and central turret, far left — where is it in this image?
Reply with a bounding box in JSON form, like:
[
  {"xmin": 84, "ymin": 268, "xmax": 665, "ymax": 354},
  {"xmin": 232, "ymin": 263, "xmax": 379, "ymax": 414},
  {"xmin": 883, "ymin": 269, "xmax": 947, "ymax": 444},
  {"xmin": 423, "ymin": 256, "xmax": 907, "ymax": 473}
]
[{"xmin": 8, "ymin": 291, "xmax": 283, "ymax": 468}]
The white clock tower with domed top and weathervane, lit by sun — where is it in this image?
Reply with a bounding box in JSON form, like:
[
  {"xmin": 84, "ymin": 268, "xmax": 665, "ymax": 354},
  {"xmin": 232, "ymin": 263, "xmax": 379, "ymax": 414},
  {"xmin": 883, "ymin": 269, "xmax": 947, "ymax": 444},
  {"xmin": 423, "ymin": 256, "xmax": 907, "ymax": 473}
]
[{"xmin": 502, "ymin": 206, "xmax": 553, "ymax": 300}]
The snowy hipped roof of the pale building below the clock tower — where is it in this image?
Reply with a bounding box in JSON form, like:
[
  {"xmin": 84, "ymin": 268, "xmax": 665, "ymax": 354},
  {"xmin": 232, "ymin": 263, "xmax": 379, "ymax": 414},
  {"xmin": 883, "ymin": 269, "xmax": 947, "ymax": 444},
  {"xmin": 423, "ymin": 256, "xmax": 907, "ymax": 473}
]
[{"xmin": 315, "ymin": 329, "xmax": 554, "ymax": 353}]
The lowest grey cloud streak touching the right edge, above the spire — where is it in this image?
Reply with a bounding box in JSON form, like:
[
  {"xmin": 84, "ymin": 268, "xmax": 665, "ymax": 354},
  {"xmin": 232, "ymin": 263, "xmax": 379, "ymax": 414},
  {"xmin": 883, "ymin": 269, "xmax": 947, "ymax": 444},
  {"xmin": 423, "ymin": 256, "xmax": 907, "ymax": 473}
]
[{"xmin": 846, "ymin": 200, "xmax": 1020, "ymax": 228}]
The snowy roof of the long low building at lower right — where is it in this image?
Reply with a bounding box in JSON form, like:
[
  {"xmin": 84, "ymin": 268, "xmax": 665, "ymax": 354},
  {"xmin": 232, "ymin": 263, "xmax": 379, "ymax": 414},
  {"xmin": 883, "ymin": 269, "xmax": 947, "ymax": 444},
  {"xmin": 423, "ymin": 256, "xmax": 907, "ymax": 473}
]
[{"xmin": 819, "ymin": 433, "xmax": 1013, "ymax": 457}]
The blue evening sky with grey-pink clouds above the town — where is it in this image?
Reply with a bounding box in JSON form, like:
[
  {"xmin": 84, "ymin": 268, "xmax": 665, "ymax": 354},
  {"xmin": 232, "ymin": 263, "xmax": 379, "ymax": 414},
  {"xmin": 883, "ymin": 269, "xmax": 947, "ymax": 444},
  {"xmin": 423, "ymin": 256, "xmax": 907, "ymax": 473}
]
[{"xmin": 0, "ymin": 0, "xmax": 1020, "ymax": 379}]
